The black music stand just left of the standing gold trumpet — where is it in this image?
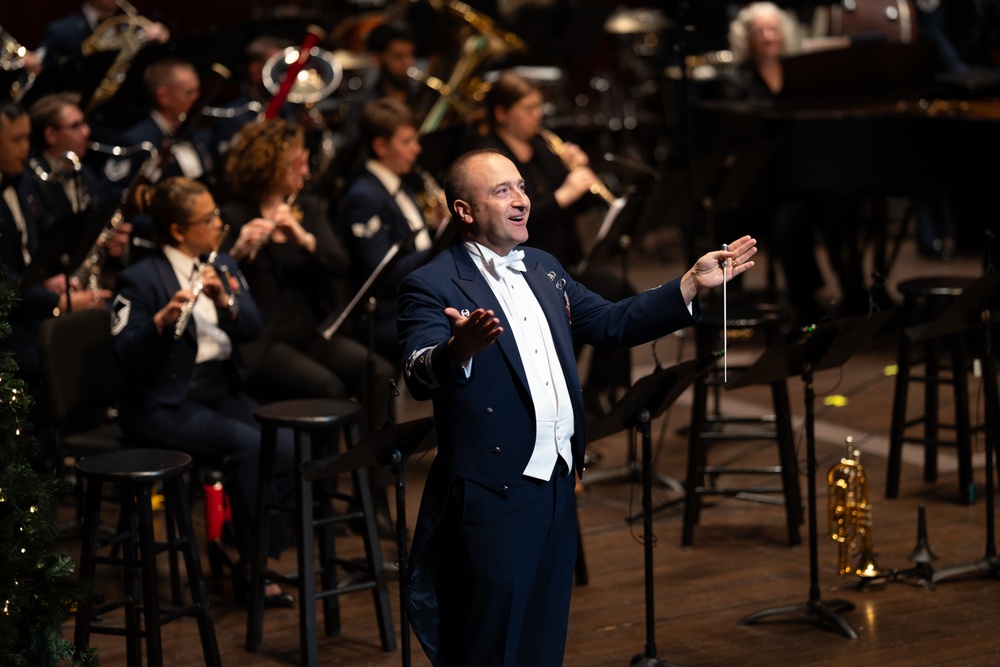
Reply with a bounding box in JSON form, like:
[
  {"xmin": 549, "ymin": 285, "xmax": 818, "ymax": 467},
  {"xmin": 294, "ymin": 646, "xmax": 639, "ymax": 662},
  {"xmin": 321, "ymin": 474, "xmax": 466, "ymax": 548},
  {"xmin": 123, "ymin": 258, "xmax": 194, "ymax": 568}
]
[{"xmin": 730, "ymin": 310, "xmax": 894, "ymax": 639}]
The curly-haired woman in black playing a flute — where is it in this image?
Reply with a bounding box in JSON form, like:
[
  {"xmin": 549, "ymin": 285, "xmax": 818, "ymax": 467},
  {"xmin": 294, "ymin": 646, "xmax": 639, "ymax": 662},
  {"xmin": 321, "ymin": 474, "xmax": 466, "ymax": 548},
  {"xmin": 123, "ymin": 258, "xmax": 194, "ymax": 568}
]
[{"xmin": 221, "ymin": 118, "xmax": 395, "ymax": 423}]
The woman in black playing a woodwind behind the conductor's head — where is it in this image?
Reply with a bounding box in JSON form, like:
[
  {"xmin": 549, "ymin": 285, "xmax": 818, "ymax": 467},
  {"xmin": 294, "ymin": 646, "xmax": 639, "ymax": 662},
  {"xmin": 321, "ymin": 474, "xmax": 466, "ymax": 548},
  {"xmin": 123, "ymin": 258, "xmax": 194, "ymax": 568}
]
[{"xmin": 471, "ymin": 71, "xmax": 635, "ymax": 410}]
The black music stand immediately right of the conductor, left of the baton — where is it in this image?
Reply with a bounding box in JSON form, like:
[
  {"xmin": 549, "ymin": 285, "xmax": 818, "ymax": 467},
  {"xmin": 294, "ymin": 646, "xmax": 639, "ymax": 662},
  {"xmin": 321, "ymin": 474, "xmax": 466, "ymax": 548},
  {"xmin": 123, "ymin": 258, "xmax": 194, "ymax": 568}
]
[{"xmin": 587, "ymin": 360, "xmax": 711, "ymax": 667}]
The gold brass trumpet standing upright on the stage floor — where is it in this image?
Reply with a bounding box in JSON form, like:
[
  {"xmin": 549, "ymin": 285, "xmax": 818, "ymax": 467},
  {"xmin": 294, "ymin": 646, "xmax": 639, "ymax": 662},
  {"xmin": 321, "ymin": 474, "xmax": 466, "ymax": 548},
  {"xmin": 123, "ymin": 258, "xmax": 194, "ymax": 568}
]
[{"xmin": 827, "ymin": 437, "xmax": 883, "ymax": 579}]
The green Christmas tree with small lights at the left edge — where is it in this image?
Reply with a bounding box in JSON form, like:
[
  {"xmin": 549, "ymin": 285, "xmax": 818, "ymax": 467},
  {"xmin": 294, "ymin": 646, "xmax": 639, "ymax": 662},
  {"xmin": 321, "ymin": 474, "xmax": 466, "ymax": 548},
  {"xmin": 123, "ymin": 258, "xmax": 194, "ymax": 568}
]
[{"xmin": 0, "ymin": 267, "xmax": 98, "ymax": 667}]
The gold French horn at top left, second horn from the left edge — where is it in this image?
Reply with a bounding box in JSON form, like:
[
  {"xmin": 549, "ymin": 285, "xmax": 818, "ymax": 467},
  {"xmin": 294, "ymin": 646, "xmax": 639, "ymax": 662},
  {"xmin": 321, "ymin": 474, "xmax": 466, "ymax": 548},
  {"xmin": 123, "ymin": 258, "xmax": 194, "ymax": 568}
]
[{"xmin": 81, "ymin": 0, "xmax": 153, "ymax": 114}]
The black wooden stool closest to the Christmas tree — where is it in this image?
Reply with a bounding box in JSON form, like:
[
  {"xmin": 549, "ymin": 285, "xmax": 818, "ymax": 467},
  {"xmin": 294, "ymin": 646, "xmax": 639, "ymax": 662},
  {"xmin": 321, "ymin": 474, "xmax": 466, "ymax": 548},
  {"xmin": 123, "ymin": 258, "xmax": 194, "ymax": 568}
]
[{"xmin": 74, "ymin": 449, "xmax": 222, "ymax": 667}]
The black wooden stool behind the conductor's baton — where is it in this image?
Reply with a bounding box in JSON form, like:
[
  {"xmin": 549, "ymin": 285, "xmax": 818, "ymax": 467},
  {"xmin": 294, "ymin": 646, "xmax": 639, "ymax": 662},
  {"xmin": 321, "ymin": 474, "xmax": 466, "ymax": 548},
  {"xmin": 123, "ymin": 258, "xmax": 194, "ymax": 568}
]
[{"xmin": 681, "ymin": 304, "xmax": 802, "ymax": 546}]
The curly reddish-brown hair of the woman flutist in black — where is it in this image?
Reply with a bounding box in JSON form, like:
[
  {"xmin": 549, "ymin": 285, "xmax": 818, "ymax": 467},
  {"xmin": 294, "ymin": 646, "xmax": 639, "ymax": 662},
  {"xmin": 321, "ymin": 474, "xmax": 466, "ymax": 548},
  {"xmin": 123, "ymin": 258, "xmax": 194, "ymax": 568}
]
[{"xmin": 226, "ymin": 118, "xmax": 305, "ymax": 202}]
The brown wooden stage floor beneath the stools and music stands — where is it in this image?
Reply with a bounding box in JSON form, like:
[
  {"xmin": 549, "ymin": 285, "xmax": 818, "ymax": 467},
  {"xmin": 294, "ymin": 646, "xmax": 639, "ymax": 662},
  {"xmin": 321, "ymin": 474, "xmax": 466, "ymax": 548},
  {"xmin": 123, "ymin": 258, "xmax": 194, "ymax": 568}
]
[{"xmin": 58, "ymin": 232, "xmax": 1000, "ymax": 667}]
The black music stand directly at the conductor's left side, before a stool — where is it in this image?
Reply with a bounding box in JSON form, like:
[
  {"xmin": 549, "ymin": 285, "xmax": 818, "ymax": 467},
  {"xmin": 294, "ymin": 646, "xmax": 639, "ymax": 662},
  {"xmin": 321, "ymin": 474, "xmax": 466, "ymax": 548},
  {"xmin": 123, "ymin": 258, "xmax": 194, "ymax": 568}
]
[{"xmin": 299, "ymin": 417, "xmax": 435, "ymax": 667}]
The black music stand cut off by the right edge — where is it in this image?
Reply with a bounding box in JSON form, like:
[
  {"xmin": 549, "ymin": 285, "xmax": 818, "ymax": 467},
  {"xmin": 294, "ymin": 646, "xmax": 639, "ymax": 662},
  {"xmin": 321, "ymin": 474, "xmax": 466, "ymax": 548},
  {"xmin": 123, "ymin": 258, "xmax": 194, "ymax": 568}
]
[{"xmin": 906, "ymin": 273, "xmax": 1000, "ymax": 584}]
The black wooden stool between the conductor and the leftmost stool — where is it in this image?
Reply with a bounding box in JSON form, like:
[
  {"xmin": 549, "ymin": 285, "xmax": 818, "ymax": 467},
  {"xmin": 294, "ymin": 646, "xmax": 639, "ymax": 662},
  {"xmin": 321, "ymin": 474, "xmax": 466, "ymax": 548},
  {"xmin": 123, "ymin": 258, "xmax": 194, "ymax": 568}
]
[{"xmin": 246, "ymin": 399, "xmax": 396, "ymax": 667}]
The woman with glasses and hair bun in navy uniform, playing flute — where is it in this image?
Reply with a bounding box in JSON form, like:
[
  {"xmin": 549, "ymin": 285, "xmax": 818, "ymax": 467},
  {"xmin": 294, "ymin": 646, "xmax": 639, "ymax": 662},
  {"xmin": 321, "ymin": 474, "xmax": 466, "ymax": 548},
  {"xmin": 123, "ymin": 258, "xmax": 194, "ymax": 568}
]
[{"xmin": 111, "ymin": 177, "xmax": 297, "ymax": 607}]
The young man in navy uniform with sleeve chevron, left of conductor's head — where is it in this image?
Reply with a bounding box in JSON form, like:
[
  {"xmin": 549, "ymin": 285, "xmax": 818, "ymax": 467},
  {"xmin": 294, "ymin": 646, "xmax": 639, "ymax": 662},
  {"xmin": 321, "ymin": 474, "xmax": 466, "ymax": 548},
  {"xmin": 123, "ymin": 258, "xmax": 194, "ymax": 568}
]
[{"xmin": 337, "ymin": 97, "xmax": 447, "ymax": 368}]
